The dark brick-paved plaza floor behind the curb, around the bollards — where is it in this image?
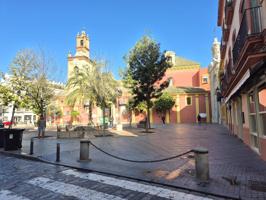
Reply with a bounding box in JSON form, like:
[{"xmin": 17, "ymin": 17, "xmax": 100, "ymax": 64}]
[{"xmin": 1, "ymin": 124, "xmax": 266, "ymax": 199}]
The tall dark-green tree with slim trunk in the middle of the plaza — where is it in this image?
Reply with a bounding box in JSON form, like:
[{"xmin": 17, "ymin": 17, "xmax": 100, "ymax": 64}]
[{"xmin": 124, "ymin": 36, "xmax": 170, "ymax": 132}]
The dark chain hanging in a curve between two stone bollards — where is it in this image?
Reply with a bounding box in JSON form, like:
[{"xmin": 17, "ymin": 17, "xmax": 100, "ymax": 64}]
[{"xmin": 90, "ymin": 141, "xmax": 193, "ymax": 163}]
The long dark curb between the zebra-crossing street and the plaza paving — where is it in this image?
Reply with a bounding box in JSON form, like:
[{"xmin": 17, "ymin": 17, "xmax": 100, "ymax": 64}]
[{"xmin": 0, "ymin": 150, "xmax": 241, "ymax": 200}]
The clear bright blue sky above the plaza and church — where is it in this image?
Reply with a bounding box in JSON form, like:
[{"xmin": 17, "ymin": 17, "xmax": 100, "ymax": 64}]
[{"xmin": 0, "ymin": 0, "xmax": 221, "ymax": 82}]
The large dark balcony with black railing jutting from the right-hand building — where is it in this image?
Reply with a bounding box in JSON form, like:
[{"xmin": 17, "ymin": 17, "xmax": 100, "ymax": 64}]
[{"xmin": 221, "ymin": 7, "xmax": 266, "ymax": 97}]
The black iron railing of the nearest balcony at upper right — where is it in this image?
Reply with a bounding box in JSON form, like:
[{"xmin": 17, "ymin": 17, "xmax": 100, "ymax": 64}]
[{"xmin": 233, "ymin": 7, "xmax": 262, "ymax": 64}]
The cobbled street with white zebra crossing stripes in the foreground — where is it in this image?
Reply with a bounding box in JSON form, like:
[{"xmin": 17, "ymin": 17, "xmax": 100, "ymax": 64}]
[{"xmin": 0, "ymin": 154, "xmax": 217, "ymax": 200}]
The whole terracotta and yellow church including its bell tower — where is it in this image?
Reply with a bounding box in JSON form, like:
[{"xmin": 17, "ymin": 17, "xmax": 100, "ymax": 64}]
[{"xmin": 50, "ymin": 31, "xmax": 212, "ymax": 125}]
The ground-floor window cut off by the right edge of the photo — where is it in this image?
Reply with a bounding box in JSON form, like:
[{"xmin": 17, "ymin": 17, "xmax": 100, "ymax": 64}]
[{"xmin": 258, "ymin": 85, "xmax": 266, "ymax": 136}]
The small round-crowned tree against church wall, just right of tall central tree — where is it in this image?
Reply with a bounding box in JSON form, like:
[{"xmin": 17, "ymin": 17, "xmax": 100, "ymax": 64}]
[{"xmin": 154, "ymin": 93, "xmax": 175, "ymax": 122}]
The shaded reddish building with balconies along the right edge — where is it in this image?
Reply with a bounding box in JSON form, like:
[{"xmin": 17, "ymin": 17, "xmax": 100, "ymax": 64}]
[{"xmin": 218, "ymin": 0, "xmax": 266, "ymax": 160}]
